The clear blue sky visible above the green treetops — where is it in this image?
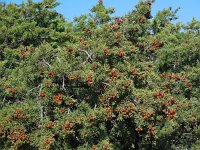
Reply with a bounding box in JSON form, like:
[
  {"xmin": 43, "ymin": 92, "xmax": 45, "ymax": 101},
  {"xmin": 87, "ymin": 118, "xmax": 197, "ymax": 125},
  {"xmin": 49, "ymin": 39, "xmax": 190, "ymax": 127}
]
[{"xmin": 3, "ymin": 0, "xmax": 200, "ymax": 23}]
